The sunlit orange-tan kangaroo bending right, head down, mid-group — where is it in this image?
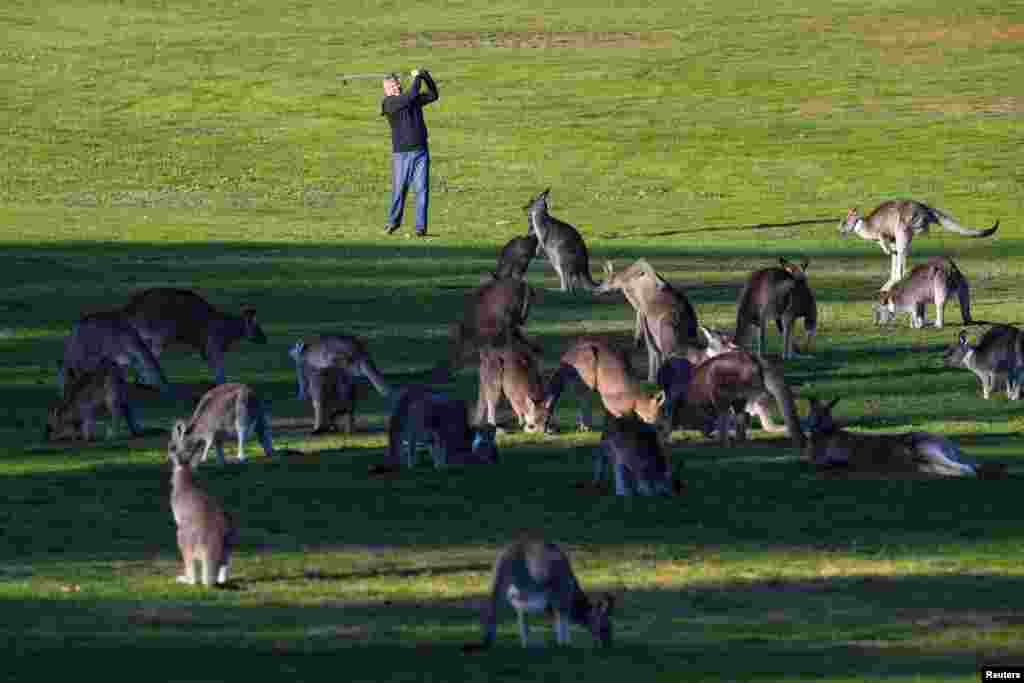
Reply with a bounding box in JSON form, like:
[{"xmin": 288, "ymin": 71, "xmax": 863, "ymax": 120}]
[{"xmin": 547, "ymin": 336, "xmax": 669, "ymax": 434}]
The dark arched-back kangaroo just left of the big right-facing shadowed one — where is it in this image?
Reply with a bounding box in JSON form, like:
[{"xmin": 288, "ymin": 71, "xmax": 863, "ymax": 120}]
[{"xmin": 57, "ymin": 311, "xmax": 172, "ymax": 394}]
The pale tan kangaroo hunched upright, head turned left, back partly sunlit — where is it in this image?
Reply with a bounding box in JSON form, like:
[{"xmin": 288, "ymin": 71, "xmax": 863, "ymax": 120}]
[{"xmin": 597, "ymin": 259, "xmax": 697, "ymax": 382}]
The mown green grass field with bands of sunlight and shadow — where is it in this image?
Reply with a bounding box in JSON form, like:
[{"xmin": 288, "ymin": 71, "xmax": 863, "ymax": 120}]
[{"xmin": 0, "ymin": 0, "xmax": 1024, "ymax": 681}]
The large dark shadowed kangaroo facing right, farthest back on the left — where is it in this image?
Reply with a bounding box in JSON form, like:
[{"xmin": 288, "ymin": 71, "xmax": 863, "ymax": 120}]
[{"xmin": 122, "ymin": 287, "xmax": 266, "ymax": 384}]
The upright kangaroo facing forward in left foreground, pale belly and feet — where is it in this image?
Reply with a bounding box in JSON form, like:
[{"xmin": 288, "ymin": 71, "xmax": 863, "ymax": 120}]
[{"xmin": 168, "ymin": 446, "xmax": 238, "ymax": 586}]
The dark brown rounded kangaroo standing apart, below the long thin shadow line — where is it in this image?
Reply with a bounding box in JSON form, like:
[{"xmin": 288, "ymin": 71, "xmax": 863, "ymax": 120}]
[{"xmin": 734, "ymin": 258, "xmax": 818, "ymax": 360}]
